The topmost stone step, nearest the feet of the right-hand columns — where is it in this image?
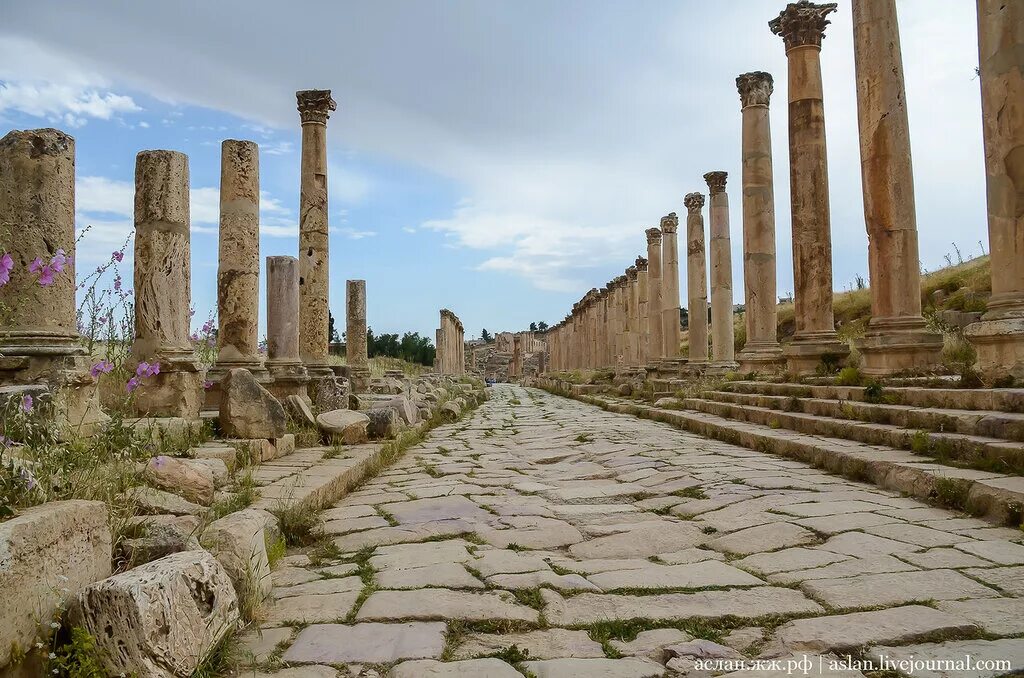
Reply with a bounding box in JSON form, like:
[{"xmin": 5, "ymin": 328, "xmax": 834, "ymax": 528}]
[{"xmin": 722, "ymin": 381, "xmax": 1024, "ymax": 413}]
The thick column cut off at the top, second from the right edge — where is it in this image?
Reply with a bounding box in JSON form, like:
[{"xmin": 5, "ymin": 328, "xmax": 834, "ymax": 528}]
[{"xmin": 853, "ymin": 0, "xmax": 942, "ymax": 375}]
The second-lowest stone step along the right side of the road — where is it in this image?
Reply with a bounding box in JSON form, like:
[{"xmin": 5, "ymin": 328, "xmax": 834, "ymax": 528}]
[{"xmin": 681, "ymin": 398, "xmax": 1024, "ymax": 475}]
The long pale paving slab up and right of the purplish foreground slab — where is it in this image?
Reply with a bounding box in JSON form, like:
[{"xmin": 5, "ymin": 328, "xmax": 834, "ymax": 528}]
[{"xmin": 355, "ymin": 589, "xmax": 538, "ymax": 623}]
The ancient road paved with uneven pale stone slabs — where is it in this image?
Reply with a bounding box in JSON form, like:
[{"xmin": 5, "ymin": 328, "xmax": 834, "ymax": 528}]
[{"xmin": 249, "ymin": 385, "xmax": 1024, "ymax": 678}]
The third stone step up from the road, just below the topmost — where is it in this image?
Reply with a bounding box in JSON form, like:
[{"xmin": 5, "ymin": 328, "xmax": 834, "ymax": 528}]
[{"xmin": 700, "ymin": 390, "xmax": 1024, "ymax": 441}]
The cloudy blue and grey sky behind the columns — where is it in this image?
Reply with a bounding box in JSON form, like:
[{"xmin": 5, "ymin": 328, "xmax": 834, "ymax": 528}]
[{"xmin": 0, "ymin": 0, "xmax": 987, "ymax": 346}]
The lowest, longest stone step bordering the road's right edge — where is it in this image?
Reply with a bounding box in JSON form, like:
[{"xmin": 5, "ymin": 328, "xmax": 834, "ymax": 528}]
[{"xmin": 575, "ymin": 395, "xmax": 1024, "ymax": 525}]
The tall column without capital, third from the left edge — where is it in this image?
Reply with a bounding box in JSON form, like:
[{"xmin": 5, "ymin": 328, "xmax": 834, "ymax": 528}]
[{"xmin": 206, "ymin": 139, "xmax": 269, "ymax": 409}]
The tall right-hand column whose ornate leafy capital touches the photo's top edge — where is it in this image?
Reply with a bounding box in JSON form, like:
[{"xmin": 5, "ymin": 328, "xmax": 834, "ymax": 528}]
[{"xmin": 769, "ymin": 0, "xmax": 850, "ymax": 374}]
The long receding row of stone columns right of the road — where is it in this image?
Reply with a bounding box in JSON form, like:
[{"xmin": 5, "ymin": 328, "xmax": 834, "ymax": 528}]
[{"xmin": 548, "ymin": 0, "xmax": 1024, "ymax": 378}]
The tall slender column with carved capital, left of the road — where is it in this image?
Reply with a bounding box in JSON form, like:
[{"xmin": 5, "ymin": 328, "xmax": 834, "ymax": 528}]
[{"xmin": 295, "ymin": 89, "xmax": 337, "ymax": 378}]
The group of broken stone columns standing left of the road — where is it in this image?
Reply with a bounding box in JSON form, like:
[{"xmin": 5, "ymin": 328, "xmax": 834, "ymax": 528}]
[{"xmin": 0, "ymin": 90, "xmax": 380, "ymax": 417}]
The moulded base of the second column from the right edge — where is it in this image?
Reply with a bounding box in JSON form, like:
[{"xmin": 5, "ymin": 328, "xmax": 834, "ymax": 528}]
[{"xmin": 857, "ymin": 316, "xmax": 943, "ymax": 377}]
